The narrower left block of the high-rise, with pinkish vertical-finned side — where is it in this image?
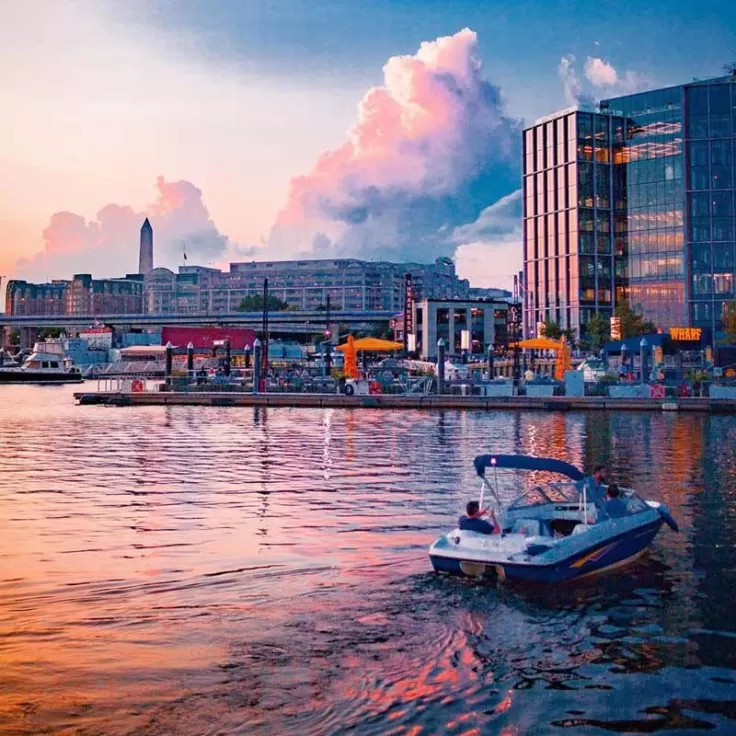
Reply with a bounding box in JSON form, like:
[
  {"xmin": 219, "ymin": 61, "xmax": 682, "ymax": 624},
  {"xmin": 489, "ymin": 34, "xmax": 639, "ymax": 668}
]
[{"xmin": 524, "ymin": 105, "xmax": 625, "ymax": 334}]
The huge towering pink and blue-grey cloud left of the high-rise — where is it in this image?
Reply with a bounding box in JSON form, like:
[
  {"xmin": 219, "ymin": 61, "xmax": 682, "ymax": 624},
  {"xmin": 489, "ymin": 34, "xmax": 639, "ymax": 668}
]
[{"xmin": 269, "ymin": 28, "xmax": 520, "ymax": 261}]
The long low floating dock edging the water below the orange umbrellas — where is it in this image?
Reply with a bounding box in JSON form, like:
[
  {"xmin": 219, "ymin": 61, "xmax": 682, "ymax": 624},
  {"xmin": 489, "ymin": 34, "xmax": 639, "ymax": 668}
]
[{"xmin": 74, "ymin": 391, "xmax": 736, "ymax": 414}]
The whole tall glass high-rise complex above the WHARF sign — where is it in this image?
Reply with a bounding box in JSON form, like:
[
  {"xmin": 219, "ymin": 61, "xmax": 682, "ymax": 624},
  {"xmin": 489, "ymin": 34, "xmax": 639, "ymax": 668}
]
[{"xmin": 523, "ymin": 75, "xmax": 736, "ymax": 342}]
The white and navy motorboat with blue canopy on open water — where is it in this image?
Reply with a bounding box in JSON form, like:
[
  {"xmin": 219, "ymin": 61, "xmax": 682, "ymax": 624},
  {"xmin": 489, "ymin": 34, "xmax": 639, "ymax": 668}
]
[{"xmin": 429, "ymin": 455, "xmax": 679, "ymax": 583}]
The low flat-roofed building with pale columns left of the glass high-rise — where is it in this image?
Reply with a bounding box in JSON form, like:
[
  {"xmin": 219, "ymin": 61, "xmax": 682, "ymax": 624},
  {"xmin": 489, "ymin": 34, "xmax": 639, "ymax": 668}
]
[{"xmin": 414, "ymin": 299, "xmax": 509, "ymax": 360}]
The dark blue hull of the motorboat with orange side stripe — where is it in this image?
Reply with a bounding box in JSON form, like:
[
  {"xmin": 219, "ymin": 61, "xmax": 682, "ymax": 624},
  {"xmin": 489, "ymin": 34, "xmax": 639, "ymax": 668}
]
[{"xmin": 430, "ymin": 517, "xmax": 664, "ymax": 584}]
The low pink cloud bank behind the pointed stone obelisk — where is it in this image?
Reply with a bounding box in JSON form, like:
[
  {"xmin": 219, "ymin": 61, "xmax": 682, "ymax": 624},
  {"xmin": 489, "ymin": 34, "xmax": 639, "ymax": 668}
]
[{"xmin": 14, "ymin": 176, "xmax": 229, "ymax": 280}]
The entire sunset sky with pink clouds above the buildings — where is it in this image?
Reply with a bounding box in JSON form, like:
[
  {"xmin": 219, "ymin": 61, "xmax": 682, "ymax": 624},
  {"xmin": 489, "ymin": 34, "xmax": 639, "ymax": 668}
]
[{"xmin": 0, "ymin": 0, "xmax": 736, "ymax": 294}]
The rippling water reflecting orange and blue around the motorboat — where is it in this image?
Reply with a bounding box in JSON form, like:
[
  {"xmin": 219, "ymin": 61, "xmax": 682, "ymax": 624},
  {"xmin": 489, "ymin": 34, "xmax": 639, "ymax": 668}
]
[{"xmin": 0, "ymin": 386, "xmax": 736, "ymax": 736}]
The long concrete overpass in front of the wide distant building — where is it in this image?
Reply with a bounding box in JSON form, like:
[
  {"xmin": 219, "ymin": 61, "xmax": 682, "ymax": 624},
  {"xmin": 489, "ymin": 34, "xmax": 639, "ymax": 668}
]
[{"xmin": 0, "ymin": 311, "xmax": 395, "ymax": 347}]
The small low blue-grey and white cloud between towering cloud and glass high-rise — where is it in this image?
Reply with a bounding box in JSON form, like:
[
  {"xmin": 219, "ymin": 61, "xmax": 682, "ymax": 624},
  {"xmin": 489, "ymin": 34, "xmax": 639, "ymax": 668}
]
[{"xmin": 452, "ymin": 189, "xmax": 523, "ymax": 289}]
